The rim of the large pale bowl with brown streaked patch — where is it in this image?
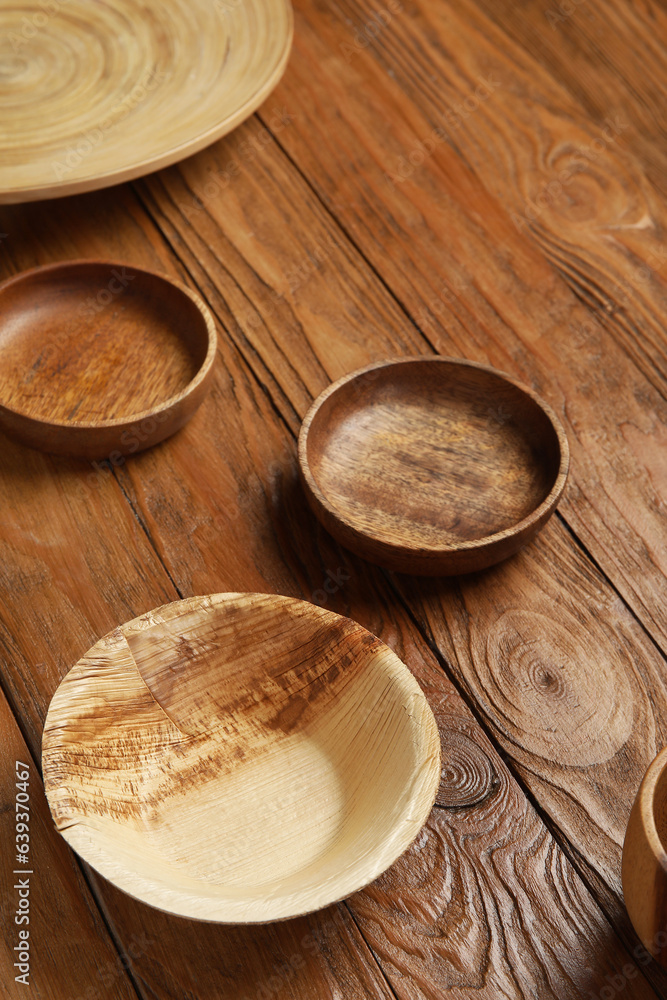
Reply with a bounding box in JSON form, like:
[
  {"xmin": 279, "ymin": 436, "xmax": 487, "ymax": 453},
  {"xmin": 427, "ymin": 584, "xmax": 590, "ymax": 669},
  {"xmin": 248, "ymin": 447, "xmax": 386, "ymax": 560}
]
[{"xmin": 40, "ymin": 592, "xmax": 442, "ymax": 924}]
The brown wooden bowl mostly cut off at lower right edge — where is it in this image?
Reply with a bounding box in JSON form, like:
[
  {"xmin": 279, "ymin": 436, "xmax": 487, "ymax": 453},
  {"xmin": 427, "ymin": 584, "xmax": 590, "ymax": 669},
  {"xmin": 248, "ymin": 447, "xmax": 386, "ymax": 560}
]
[{"xmin": 622, "ymin": 747, "xmax": 667, "ymax": 966}]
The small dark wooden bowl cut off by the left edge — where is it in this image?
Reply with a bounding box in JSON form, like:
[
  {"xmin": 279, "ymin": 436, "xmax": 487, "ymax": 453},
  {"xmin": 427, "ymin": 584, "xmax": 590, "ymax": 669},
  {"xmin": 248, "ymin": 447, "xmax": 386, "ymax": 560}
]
[{"xmin": 0, "ymin": 260, "xmax": 216, "ymax": 462}]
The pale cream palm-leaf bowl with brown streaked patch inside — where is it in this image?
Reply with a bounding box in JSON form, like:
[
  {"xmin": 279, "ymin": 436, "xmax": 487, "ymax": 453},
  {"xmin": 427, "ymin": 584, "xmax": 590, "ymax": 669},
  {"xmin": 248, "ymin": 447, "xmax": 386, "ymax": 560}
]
[{"xmin": 42, "ymin": 594, "xmax": 440, "ymax": 923}]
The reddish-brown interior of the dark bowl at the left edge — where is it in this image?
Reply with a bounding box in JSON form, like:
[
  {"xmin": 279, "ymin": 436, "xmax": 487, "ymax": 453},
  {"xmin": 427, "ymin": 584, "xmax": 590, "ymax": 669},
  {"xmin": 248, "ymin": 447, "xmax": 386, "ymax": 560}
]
[{"xmin": 0, "ymin": 262, "xmax": 208, "ymax": 425}]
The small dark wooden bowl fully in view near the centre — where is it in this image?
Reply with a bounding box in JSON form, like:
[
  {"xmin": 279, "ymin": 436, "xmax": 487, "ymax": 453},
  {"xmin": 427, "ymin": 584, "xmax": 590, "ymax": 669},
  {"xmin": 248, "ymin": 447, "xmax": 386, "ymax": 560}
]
[{"xmin": 299, "ymin": 357, "xmax": 569, "ymax": 576}]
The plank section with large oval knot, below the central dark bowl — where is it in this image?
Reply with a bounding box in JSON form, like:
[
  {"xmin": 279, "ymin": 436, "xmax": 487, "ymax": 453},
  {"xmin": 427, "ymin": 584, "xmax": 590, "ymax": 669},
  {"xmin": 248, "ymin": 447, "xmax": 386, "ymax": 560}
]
[{"xmin": 398, "ymin": 521, "xmax": 667, "ymax": 897}]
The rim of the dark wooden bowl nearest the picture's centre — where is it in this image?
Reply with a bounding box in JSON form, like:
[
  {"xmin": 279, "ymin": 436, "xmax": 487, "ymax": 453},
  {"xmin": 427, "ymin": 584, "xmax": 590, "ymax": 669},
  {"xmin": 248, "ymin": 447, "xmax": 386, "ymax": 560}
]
[{"xmin": 298, "ymin": 354, "xmax": 570, "ymax": 555}]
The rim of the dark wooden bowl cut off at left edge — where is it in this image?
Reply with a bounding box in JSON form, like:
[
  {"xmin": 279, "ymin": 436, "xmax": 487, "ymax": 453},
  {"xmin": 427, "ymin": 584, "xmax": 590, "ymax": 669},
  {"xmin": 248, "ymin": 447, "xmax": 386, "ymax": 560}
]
[{"xmin": 0, "ymin": 257, "xmax": 218, "ymax": 433}]
